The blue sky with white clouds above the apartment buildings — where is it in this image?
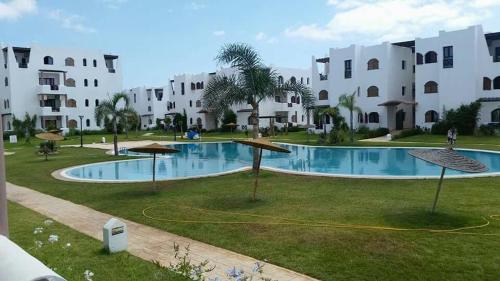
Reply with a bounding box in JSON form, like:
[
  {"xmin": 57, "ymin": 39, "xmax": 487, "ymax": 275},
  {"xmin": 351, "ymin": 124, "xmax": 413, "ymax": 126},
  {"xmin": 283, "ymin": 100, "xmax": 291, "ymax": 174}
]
[{"xmin": 0, "ymin": 0, "xmax": 500, "ymax": 88}]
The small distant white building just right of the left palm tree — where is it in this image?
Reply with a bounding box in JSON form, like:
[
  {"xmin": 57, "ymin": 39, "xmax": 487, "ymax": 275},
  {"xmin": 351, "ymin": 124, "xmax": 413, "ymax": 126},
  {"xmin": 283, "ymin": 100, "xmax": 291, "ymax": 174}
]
[{"xmin": 125, "ymin": 87, "xmax": 170, "ymax": 129}]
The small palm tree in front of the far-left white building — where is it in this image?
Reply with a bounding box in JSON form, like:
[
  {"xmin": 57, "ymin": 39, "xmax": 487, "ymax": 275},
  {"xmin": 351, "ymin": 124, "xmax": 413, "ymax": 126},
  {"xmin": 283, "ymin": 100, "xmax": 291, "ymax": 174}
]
[{"xmin": 94, "ymin": 93, "xmax": 137, "ymax": 155}]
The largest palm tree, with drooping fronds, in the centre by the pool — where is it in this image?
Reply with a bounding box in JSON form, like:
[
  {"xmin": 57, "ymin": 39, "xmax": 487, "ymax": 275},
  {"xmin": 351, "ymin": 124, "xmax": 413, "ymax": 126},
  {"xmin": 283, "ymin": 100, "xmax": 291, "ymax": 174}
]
[{"xmin": 203, "ymin": 43, "xmax": 314, "ymax": 171}]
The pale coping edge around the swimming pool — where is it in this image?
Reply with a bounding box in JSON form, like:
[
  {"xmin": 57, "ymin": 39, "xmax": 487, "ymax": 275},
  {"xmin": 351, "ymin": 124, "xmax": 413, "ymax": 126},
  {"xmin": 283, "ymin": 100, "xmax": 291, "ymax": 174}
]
[{"xmin": 51, "ymin": 141, "xmax": 500, "ymax": 183}]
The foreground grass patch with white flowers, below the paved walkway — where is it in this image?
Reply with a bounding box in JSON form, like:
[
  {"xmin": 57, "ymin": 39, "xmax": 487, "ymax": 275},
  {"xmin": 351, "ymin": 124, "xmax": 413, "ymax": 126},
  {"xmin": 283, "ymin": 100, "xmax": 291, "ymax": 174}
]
[{"xmin": 8, "ymin": 203, "xmax": 186, "ymax": 281}]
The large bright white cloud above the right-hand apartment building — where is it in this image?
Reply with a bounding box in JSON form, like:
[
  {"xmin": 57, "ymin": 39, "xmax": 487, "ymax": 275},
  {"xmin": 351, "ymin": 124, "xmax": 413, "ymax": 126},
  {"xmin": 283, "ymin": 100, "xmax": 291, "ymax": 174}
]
[{"xmin": 284, "ymin": 0, "xmax": 500, "ymax": 41}]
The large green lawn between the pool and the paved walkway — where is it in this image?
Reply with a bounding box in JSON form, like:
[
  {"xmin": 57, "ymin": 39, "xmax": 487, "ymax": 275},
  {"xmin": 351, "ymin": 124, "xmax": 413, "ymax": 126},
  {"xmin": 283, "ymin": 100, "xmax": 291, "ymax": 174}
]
[{"xmin": 6, "ymin": 137, "xmax": 500, "ymax": 280}]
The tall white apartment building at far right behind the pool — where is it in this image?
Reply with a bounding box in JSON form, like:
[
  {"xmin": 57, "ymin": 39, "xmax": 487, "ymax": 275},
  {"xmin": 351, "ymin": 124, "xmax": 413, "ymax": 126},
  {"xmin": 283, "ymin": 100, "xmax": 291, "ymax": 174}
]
[{"xmin": 312, "ymin": 26, "xmax": 500, "ymax": 130}]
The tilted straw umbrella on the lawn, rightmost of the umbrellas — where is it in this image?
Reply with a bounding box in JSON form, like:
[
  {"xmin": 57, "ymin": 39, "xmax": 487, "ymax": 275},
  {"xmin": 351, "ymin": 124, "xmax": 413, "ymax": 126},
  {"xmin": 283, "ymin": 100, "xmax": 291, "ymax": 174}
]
[{"xmin": 408, "ymin": 148, "xmax": 488, "ymax": 213}]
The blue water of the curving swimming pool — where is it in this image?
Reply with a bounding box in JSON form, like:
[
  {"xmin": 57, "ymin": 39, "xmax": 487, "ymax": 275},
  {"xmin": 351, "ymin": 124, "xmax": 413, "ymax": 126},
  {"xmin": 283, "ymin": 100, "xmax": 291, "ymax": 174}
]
[{"xmin": 63, "ymin": 143, "xmax": 500, "ymax": 181}]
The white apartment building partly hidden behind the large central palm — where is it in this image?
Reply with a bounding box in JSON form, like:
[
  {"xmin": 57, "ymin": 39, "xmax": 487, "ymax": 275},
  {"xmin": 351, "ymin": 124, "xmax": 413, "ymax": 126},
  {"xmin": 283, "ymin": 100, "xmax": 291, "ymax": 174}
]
[{"xmin": 166, "ymin": 67, "xmax": 311, "ymax": 130}]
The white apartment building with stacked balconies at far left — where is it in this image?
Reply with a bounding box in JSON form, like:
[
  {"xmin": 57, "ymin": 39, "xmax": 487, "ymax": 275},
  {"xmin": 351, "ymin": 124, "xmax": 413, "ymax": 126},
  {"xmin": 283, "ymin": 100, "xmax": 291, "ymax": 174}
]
[{"xmin": 0, "ymin": 45, "xmax": 123, "ymax": 131}]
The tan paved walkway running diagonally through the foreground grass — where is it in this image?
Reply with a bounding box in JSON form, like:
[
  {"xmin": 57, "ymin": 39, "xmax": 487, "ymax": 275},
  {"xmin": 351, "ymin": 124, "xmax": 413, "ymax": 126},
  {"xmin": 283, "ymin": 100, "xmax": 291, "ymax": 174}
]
[{"xmin": 7, "ymin": 183, "xmax": 316, "ymax": 281}]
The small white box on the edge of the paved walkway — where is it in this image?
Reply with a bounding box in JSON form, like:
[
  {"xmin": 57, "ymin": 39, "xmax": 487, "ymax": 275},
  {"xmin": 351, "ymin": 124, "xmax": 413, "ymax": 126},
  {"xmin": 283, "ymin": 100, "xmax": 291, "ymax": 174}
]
[{"xmin": 102, "ymin": 218, "xmax": 128, "ymax": 253}]
